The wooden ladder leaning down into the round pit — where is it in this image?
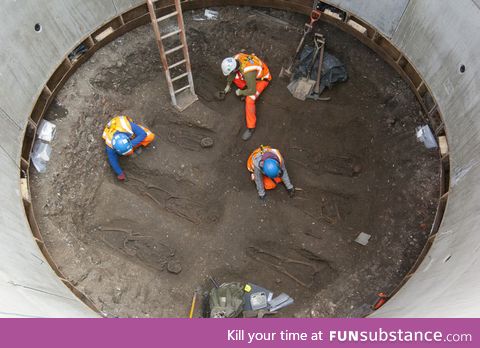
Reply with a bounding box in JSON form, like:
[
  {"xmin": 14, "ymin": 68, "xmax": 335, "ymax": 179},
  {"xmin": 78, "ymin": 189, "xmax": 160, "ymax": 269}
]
[{"xmin": 147, "ymin": 0, "xmax": 198, "ymax": 111}]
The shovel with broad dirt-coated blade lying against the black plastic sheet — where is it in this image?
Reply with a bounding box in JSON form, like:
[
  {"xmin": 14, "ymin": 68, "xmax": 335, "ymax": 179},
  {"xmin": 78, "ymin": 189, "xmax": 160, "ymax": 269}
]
[{"xmin": 287, "ymin": 33, "xmax": 328, "ymax": 100}]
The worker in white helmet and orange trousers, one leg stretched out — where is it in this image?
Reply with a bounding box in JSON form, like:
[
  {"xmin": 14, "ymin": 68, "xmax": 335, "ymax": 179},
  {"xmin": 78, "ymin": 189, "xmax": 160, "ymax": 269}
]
[{"xmin": 222, "ymin": 53, "xmax": 272, "ymax": 140}]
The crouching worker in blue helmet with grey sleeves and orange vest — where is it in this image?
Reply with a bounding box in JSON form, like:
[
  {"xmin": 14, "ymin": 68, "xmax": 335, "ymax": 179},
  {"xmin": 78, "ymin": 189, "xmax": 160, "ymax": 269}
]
[{"xmin": 247, "ymin": 145, "xmax": 295, "ymax": 200}]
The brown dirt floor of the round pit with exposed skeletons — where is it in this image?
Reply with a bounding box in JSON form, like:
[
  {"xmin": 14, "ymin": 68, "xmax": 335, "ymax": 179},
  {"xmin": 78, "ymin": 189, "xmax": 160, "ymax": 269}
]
[{"xmin": 31, "ymin": 7, "xmax": 439, "ymax": 317}]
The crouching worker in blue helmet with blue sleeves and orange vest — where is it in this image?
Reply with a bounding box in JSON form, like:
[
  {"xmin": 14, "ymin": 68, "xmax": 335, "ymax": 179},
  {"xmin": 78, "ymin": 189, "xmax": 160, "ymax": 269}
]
[{"xmin": 102, "ymin": 116, "xmax": 155, "ymax": 181}]
